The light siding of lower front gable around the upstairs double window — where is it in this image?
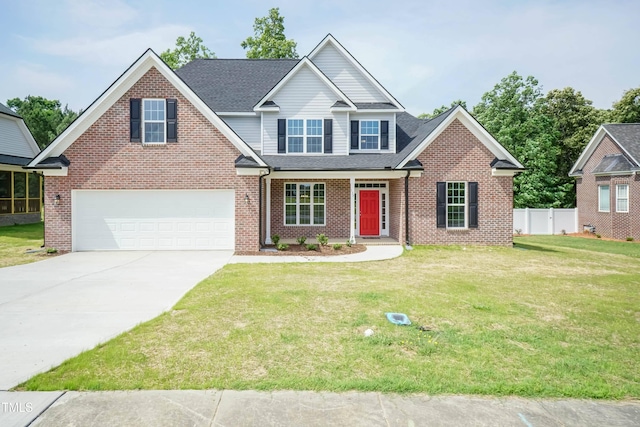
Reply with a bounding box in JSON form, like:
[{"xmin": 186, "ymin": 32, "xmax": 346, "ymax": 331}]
[{"xmin": 263, "ymin": 66, "xmax": 349, "ymax": 155}]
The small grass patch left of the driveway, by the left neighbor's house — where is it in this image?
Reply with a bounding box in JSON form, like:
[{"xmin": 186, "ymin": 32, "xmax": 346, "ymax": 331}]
[{"xmin": 0, "ymin": 222, "xmax": 44, "ymax": 268}]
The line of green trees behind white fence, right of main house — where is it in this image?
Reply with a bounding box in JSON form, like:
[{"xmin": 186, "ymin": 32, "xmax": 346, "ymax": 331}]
[{"xmin": 419, "ymin": 75, "xmax": 640, "ymax": 208}]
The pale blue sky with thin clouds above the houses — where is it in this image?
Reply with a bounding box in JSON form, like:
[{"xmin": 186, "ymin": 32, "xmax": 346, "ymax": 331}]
[{"xmin": 0, "ymin": 0, "xmax": 640, "ymax": 114}]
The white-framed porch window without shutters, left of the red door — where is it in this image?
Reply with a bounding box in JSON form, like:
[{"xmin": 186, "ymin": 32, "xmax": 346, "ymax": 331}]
[{"xmin": 284, "ymin": 182, "xmax": 326, "ymax": 225}]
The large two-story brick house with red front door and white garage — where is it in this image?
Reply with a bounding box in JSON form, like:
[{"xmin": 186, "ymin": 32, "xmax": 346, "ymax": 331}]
[{"xmin": 29, "ymin": 35, "xmax": 522, "ymax": 251}]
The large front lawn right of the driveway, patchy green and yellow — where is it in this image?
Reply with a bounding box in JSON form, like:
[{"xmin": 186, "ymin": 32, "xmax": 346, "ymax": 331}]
[{"xmin": 19, "ymin": 236, "xmax": 640, "ymax": 399}]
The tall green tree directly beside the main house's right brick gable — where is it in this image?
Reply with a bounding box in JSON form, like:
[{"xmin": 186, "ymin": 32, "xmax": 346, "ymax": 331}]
[{"xmin": 473, "ymin": 71, "xmax": 573, "ymax": 208}]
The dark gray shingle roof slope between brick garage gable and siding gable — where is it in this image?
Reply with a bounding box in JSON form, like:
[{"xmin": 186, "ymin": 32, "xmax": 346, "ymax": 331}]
[{"xmin": 176, "ymin": 59, "xmax": 298, "ymax": 112}]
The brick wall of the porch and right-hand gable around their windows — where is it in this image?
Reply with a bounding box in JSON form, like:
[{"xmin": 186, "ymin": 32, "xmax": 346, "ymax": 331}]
[{"xmin": 264, "ymin": 120, "xmax": 513, "ymax": 245}]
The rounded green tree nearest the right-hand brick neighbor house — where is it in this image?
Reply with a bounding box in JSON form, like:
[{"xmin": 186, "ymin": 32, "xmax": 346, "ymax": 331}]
[{"xmin": 539, "ymin": 87, "xmax": 608, "ymax": 207}]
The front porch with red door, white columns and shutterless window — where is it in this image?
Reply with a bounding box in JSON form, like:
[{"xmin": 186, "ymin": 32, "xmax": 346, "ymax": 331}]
[{"xmin": 261, "ymin": 174, "xmax": 406, "ymax": 245}]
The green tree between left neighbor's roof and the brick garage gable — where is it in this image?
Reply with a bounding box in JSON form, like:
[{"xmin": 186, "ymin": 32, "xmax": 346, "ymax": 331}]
[{"xmin": 7, "ymin": 95, "xmax": 79, "ymax": 148}]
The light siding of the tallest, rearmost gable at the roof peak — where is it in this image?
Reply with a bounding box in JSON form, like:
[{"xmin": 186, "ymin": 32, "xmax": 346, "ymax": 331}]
[{"xmin": 312, "ymin": 43, "xmax": 389, "ymax": 102}]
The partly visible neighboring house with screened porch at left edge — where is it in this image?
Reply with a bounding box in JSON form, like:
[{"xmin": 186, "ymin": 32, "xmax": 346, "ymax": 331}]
[{"xmin": 0, "ymin": 104, "xmax": 42, "ymax": 226}]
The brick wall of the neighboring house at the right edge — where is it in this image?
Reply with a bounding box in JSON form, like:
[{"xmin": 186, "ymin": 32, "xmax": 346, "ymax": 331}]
[{"xmin": 576, "ymin": 134, "xmax": 640, "ymax": 240}]
